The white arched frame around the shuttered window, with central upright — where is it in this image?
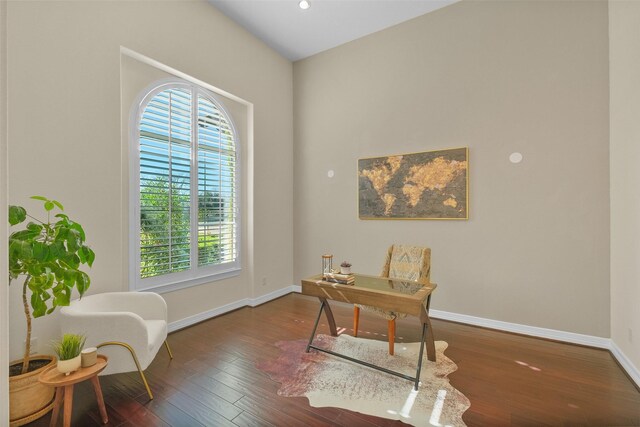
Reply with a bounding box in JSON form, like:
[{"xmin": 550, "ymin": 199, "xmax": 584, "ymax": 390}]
[{"xmin": 129, "ymin": 78, "xmax": 243, "ymax": 293}]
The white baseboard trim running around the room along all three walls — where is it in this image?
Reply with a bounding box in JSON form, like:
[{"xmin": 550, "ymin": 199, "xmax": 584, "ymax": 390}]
[{"xmin": 168, "ymin": 285, "xmax": 640, "ymax": 387}]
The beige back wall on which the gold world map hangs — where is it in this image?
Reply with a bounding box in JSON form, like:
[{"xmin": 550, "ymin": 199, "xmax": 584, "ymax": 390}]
[{"xmin": 294, "ymin": 1, "xmax": 609, "ymax": 337}]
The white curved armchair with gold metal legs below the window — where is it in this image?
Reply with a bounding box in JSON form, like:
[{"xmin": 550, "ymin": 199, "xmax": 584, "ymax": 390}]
[{"xmin": 60, "ymin": 292, "xmax": 173, "ymax": 399}]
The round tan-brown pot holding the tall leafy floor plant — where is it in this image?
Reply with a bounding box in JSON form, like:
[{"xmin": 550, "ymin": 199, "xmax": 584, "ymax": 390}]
[{"xmin": 9, "ymin": 354, "xmax": 56, "ymax": 427}]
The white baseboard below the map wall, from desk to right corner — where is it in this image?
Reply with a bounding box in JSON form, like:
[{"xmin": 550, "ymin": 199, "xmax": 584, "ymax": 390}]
[{"xmin": 429, "ymin": 310, "xmax": 611, "ymax": 350}]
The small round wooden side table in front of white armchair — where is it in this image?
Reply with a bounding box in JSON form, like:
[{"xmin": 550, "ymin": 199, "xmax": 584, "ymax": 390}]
[{"xmin": 38, "ymin": 354, "xmax": 109, "ymax": 427}]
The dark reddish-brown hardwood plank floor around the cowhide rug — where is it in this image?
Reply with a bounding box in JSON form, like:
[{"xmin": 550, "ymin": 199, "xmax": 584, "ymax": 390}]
[{"xmin": 30, "ymin": 294, "xmax": 640, "ymax": 427}]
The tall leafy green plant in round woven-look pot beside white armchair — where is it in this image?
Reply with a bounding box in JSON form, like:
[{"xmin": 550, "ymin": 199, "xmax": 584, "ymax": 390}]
[{"xmin": 9, "ymin": 196, "xmax": 95, "ymax": 426}]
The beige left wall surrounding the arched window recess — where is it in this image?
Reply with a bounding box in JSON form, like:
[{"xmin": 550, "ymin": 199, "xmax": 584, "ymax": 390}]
[{"xmin": 8, "ymin": 1, "xmax": 293, "ymax": 362}]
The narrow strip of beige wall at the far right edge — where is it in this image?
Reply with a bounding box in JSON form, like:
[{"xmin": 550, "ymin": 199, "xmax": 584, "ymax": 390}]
[{"xmin": 609, "ymin": 0, "xmax": 640, "ymax": 373}]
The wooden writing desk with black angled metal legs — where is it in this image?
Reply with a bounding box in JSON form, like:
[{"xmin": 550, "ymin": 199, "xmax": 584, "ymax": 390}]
[{"xmin": 302, "ymin": 274, "xmax": 437, "ymax": 390}]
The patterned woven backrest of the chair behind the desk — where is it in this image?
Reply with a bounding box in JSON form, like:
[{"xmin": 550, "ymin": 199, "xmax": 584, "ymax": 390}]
[{"xmin": 381, "ymin": 245, "xmax": 431, "ymax": 283}]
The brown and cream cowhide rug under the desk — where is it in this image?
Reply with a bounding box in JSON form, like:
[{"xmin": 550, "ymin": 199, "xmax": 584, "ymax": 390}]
[{"xmin": 257, "ymin": 335, "xmax": 470, "ymax": 426}]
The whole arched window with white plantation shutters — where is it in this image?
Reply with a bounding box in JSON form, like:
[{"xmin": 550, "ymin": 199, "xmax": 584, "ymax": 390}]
[{"xmin": 131, "ymin": 82, "xmax": 240, "ymax": 290}]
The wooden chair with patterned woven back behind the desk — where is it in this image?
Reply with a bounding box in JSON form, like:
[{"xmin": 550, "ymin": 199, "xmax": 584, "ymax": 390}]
[{"xmin": 353, "ymin": 245, "xmax": 431, "ymax": 355}]
